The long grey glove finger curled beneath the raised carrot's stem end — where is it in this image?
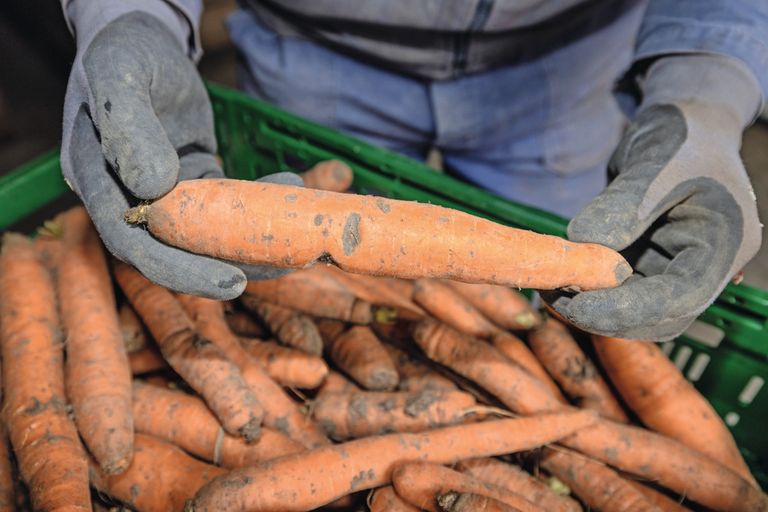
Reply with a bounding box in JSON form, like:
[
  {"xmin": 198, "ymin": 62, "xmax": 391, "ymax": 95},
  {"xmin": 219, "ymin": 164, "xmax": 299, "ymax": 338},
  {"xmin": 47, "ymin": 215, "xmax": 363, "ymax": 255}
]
[{"xmin": 70, "ymin": 109, "xmax": 246, "ymax": 300}]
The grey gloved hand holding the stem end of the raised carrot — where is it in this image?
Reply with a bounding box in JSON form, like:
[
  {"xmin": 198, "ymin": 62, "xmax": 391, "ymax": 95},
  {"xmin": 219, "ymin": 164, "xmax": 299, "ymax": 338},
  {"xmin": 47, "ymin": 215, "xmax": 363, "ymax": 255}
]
[{"xmin": 62, "ymin": 7, "xmax": 301, "ymax": 300}]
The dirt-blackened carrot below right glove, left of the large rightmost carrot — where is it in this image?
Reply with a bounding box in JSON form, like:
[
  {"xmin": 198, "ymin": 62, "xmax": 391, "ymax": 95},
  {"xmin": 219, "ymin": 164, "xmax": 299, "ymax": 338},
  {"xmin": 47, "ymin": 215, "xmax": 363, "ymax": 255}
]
[{"xmin": 528, "ymin": 318, "xmax": 629, "ymax": 423}]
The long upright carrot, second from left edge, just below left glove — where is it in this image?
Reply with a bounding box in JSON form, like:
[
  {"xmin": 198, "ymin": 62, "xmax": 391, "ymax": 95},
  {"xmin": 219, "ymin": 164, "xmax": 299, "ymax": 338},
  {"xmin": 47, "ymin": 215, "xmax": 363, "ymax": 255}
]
[{"xmin": 57, "ymin": 207, "xmax": 133, "ymax": 474}]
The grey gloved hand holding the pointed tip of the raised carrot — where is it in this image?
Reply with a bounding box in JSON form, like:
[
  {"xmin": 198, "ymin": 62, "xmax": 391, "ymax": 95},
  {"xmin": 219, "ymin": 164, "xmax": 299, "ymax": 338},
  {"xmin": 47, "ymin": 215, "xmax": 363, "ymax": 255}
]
[{"xmin": 542, "ymin": 55, "xmax": 762, "ymax": 341}]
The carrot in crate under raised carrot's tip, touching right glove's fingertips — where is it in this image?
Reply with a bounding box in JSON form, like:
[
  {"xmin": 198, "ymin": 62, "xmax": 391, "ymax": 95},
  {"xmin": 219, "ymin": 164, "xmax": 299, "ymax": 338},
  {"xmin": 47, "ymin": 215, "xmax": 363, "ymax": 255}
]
[{"xmin": 446, "ymin": 281, "xmax": 541, "ymax": 330}]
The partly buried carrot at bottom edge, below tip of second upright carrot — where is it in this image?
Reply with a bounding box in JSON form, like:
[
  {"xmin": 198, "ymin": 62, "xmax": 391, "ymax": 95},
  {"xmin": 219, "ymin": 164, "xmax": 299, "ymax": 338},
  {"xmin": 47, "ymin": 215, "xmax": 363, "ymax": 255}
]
[{"xmin": 91, "ymin": 433, "xmax": 226, "ymax": 512}]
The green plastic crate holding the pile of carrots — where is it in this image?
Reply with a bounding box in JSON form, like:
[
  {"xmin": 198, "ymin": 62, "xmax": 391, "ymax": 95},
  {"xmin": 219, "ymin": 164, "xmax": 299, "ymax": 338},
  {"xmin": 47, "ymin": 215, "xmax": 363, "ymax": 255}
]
[{"xmin": 0, "ymin": 85, "xmax": 768, "ymax": 489}]
